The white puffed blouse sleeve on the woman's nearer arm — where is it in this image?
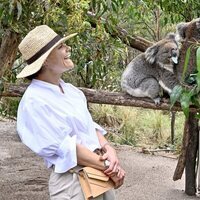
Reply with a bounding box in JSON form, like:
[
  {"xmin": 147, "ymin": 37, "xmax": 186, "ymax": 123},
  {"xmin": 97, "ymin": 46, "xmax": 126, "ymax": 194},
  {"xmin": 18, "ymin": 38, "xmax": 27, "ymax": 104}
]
[{"xmin": 17, "ymin": 100, "xmax": 77, "ymax": 173}]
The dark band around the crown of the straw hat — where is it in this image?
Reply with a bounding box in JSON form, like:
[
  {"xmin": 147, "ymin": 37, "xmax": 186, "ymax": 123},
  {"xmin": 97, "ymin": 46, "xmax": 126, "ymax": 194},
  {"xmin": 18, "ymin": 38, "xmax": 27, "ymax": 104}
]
[{"xmin": 26, "ymin": 35, "xmax": 62, "ymax": 65}]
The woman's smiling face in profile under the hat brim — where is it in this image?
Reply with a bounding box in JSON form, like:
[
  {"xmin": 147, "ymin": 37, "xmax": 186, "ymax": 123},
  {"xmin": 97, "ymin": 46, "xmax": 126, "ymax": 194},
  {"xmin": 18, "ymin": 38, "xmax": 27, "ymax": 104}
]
[{"xmin": 44, "ymin": 43, "xmax": 74, "ymax": 74}]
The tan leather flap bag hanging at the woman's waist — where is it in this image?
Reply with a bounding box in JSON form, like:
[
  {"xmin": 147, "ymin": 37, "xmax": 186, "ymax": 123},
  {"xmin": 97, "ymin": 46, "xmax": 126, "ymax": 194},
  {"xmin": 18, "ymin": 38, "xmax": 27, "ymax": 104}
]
[{"xmin": 78, "ymin": 167, "xmax": 114, "ymax": 200}]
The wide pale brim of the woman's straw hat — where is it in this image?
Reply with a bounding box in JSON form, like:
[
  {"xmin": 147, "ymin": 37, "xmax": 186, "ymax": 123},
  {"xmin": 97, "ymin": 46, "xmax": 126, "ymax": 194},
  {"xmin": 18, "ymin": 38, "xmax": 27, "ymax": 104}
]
[{"xmin": 17, "ymin": 33, "xmax": 77, "ymax": 78}]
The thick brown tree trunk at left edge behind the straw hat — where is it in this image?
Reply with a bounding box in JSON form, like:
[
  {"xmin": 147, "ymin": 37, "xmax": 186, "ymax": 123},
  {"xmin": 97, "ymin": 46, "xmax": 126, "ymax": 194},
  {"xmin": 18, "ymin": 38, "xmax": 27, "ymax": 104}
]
[{"xmin": 0, "ymin": 29, "xmax": 20, "ymax": 78}]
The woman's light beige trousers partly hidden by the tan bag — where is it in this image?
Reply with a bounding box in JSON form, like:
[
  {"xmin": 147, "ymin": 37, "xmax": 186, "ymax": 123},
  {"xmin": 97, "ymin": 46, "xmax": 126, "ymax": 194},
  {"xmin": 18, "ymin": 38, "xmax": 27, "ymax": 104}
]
[{"xmin": 49, "ymin": 170, "xmax": 115, "ymax": 200}]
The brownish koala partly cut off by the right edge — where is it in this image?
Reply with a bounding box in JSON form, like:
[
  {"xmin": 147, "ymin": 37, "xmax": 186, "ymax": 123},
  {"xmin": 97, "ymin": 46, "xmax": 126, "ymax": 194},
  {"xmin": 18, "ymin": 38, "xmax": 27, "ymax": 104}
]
[{"xmin": 174, "ymin": 18, "xmax": 200, "ymax": 84}]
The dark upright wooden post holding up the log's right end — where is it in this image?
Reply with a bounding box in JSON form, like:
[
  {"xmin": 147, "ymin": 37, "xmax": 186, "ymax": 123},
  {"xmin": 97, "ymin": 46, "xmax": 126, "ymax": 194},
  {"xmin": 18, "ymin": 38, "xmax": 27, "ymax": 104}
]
[{"xmin": 185, "ymin": 113, "xmax": 199, "ymax": 196}]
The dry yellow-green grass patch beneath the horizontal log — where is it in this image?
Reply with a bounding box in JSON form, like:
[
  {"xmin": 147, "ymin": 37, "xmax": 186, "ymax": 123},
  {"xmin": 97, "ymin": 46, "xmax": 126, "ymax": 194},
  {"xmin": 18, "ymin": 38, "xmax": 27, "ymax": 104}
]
[{"xmin": 90, "ymin": 104, "xmax": 184, "ymax": 150}]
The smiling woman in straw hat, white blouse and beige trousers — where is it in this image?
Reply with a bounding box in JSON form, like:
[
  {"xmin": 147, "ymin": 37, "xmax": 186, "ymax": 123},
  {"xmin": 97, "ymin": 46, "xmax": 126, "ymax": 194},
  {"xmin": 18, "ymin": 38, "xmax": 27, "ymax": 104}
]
[{"xmin": 17, "ymin": 25, "xmax": 125, "ymax": 200}]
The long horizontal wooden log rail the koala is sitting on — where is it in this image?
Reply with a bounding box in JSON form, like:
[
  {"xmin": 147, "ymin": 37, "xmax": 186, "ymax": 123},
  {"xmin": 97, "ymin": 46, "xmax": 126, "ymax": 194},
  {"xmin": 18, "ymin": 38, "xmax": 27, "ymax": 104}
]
[{"xmin": 1, "ymin": 84, "xmax": 197, "ymax": 112}]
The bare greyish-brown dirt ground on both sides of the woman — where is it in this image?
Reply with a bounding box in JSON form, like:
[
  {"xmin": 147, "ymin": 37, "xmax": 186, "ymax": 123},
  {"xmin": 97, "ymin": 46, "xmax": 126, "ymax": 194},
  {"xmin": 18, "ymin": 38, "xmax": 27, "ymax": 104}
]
[{"xmin": 0, "ymin": 120, "xmax": 198, "ymax": 200}]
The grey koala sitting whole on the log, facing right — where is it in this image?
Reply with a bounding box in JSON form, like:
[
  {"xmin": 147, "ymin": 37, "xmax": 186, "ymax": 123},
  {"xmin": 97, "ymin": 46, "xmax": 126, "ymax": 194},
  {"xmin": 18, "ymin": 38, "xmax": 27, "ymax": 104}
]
[{"xmin": 121, "ymin": 33, "xmax": 179, "ymax": 104}]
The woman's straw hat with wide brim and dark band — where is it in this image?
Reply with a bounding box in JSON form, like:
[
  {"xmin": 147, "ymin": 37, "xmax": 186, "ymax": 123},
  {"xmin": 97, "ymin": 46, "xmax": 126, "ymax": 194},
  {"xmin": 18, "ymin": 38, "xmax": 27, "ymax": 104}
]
[{"xmin": 17, "ymin": 25, "xmax": 77, "ymax": 78}]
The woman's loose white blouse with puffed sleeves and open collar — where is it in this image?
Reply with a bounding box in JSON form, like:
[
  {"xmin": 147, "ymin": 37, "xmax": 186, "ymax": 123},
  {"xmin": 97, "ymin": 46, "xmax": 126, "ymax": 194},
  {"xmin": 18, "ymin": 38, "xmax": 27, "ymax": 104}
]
[{"xmin": 17, "ymin": 79, "xmax": 106, "ymax": 173}]
